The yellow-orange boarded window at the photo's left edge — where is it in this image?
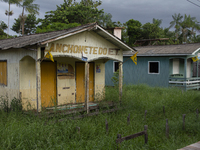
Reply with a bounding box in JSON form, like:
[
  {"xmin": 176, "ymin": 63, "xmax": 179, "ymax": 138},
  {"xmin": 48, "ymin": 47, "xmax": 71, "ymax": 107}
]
[{"xmin": 0, "ymin": 61, "xmax": 7, "ymax": 85}]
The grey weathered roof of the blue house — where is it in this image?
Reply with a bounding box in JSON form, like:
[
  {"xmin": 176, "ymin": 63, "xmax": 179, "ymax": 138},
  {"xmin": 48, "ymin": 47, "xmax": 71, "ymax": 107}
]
[{"xmin": 123, "ymin": 43, "xmax": 200, "ymax": 56}]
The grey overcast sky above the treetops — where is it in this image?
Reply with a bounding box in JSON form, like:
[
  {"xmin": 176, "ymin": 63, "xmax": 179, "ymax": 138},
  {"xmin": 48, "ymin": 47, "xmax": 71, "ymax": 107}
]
[{"xmin": 0, "ymin": 0, "xmax": 200, "ymax": 35}]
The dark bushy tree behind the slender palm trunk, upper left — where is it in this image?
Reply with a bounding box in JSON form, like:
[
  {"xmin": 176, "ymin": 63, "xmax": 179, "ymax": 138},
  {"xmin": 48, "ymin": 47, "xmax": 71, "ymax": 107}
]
[{"xmin": 11, "ymin": 14, "xmax": 38, "ymax": 35}]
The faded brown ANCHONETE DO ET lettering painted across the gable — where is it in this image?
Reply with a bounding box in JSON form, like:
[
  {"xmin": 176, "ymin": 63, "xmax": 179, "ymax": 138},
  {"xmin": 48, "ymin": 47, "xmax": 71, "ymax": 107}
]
[{"xmin": 45, "ymin": 43, "xmax": 120, "ymax": 55}]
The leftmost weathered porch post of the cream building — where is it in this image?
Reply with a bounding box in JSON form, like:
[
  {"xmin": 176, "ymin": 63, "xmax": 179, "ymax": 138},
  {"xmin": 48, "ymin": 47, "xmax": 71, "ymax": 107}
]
[{"xmin": 36, "ymin": 47, "xmax": 41, "ymax": 112}]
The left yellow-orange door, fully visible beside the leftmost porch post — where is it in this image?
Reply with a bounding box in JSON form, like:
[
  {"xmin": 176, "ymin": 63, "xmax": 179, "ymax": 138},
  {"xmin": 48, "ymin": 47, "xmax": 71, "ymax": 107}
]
[{"xmin": 41, "ymin": 62, "xmax": 57, "ymax": 107}]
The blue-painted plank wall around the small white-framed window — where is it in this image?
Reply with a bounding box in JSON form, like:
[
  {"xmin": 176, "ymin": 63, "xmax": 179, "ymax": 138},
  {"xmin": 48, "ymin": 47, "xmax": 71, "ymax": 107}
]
[{"xmin": 105, "ymin": 56, "xmax": 170, "ymax": 87}]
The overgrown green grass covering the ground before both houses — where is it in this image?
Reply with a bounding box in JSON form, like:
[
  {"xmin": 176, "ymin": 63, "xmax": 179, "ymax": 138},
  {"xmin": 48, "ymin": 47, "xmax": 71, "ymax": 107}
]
[{"xmin": 0, "ymin": 85, "xmax": 200, "ymax": 150}]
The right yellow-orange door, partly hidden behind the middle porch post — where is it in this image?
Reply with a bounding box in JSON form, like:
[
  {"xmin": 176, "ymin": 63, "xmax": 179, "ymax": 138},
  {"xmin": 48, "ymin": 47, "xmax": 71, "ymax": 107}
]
[{"xmin": 76, "ymin": 63, "xmax": 94, "ymax": 103}]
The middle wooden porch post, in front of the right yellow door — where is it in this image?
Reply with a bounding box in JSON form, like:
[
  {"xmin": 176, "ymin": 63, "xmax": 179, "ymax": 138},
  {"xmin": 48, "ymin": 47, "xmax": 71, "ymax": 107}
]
[{"xmin": 85, "ymin": 62, "xmax": 90, "ymax": 114}]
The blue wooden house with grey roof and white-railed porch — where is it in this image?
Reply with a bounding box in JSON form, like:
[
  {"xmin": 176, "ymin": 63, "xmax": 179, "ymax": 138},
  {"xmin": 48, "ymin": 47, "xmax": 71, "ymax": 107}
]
[{"xmin": 105, "ymin": 43, "xmax": 200, "ymax": 90}]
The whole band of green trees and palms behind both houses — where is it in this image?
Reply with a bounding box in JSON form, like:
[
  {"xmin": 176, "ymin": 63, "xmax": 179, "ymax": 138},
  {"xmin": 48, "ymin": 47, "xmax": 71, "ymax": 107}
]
[{"xmin": 0, "ymin": 0, "xmax": 200, "ymax": 46}]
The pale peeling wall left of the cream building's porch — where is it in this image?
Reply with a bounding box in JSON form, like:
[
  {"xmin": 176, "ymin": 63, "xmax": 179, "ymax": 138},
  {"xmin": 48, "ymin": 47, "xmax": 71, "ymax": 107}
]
[{"xmin": 0, "ymin": 49, "xmax": 36, "ymax": 104}]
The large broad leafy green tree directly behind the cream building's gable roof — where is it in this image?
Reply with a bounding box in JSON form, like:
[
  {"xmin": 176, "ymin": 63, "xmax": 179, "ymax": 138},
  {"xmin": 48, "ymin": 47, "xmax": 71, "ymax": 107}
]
[{"xmin": 39, "ymin": 0, "xmax": 103, "ymax": 28}]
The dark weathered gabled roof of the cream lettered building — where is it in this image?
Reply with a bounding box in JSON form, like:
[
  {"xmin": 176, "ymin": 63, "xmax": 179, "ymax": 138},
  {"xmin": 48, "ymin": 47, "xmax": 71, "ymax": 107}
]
[{"xmin": 0, "ymin": 23, "xmax": 134, "ymax": 51}]
